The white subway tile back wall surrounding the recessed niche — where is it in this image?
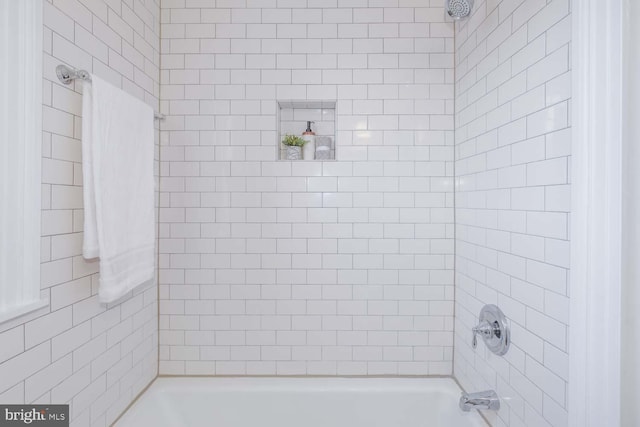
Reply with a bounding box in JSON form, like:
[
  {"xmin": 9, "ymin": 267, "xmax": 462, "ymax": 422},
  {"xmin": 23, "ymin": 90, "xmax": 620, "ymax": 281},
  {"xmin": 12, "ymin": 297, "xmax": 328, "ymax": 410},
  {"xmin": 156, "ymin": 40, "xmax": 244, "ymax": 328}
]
[{"xmin": 159, "ymin": 0, "xmax": 460, "ymax": 375}]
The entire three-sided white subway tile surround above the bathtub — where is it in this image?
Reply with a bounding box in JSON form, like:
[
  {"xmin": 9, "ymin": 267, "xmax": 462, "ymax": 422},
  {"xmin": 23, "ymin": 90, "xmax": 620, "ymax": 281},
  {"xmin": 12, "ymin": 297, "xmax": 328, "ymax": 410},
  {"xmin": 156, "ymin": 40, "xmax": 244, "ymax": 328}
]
[{"xmin": 0, "ymin": 0, "xmax": 571, "ymax": 427}]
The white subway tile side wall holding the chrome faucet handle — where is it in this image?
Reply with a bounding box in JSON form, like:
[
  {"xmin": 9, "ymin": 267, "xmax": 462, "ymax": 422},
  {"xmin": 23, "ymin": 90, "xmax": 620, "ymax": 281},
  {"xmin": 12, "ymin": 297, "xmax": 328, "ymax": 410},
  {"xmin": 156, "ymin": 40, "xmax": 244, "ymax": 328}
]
[{"xmin": 454, "ymin": 0, "xmax": 571, "ymax": 427}]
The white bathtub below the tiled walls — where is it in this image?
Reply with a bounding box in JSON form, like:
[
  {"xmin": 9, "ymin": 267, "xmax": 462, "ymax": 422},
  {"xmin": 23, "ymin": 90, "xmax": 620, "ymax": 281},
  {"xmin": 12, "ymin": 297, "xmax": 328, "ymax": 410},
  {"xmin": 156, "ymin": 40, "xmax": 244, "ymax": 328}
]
[{"xmin": 115, "ymin": 378, "xmax": 486, "ymax": 427}]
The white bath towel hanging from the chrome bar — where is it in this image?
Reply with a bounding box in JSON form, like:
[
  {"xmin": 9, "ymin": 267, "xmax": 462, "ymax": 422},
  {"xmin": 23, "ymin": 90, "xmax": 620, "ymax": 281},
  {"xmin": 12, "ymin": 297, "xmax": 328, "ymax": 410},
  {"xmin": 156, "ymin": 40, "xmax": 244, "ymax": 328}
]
[{"xmin": 82, "ymin": 75, "xmax": 155, "ymax": 303}]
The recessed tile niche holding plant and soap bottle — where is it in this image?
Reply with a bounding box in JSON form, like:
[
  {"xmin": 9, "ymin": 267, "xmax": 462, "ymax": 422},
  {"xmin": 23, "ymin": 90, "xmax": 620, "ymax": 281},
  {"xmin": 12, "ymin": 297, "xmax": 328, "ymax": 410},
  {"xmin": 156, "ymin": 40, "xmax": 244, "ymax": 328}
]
[{"xmin": 277, "ymin": 101, "xmax": 336, "ymax": 161}]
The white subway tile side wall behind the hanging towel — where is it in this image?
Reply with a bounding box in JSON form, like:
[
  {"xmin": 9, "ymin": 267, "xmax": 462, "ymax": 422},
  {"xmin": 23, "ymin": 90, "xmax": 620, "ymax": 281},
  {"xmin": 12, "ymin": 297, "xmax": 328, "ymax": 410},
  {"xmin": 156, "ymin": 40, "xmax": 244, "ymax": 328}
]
[{"xmin": 0, "ymin": 0, "xmax": 160, "ymax": 427}]
